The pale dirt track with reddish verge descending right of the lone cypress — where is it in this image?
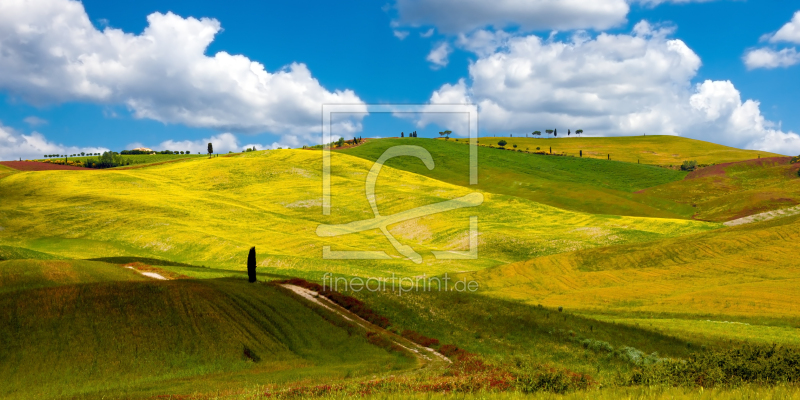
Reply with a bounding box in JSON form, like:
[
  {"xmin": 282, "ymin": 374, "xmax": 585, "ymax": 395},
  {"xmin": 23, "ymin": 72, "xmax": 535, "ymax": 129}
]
[{"xmin": 281, "ymin": 283, "xmax": 452, "ymax": 364}]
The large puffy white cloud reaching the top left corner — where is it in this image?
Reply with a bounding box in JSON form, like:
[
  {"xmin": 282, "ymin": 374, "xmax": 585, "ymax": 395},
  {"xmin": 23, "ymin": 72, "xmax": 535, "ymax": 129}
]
[{"xmin": 0, "ymin": 0, "xmax": 362, "ymax": 141}]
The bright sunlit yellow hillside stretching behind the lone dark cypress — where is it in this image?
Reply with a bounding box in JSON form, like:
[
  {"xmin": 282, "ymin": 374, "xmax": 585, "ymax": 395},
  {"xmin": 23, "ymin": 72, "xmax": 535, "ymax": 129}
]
[{"xmin": 0, "ymin": 149, "xmax": 717, "ymax": 277}]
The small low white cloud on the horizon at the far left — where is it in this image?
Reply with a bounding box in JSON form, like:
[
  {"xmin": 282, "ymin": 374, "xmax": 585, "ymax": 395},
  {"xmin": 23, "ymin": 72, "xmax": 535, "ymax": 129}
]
[{"xmin": 0, "ymin": 125, "xmax": 108, "ymax": 161}]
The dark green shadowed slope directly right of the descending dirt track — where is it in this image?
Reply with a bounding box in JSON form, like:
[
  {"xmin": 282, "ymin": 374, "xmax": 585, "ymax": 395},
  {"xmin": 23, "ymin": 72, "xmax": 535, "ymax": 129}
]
[{"xmin": 349, "ymin": 291, "xmax": 704, "ymax": 384}]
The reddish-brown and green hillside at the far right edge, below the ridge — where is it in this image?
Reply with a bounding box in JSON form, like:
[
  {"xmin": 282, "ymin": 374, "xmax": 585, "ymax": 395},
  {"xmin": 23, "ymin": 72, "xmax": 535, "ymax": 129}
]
[{"xmin": 643, "ymin": 157, "xmax": 800, "ymax": 221}]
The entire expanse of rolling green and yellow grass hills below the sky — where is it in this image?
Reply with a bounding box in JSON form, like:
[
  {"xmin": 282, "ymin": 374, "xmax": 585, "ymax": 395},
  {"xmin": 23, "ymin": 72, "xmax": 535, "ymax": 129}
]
[{"xmin": 0, "ymin": 136, "xmax": 800, "ymax": 399}]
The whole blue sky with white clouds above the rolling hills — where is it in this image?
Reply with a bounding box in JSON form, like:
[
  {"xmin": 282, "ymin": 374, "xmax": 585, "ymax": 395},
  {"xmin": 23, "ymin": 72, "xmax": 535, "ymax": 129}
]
[{"xmin": 0, "ymin": 0, "xmax": 800, "ymax": 159}]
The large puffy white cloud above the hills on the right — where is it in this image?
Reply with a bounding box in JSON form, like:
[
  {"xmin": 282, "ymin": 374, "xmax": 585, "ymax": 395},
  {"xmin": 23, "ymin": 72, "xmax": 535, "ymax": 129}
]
[{"xmin": 418, "ymin": 21, "xmax": 800, "ymax": 154}]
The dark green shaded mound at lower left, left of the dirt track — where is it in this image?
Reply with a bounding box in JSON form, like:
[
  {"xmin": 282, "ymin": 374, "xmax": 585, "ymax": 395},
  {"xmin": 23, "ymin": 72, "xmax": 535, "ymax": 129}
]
[{"xmin": 0, "ymin": 268, "xmax": 415, "ymax": 399}]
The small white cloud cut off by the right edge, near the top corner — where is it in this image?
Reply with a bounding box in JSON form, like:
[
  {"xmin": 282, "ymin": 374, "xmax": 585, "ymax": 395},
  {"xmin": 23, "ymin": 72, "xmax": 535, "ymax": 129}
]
[{"xmin": 743, "ymin": 11, "xmax": 800, "ymax": 69}]
